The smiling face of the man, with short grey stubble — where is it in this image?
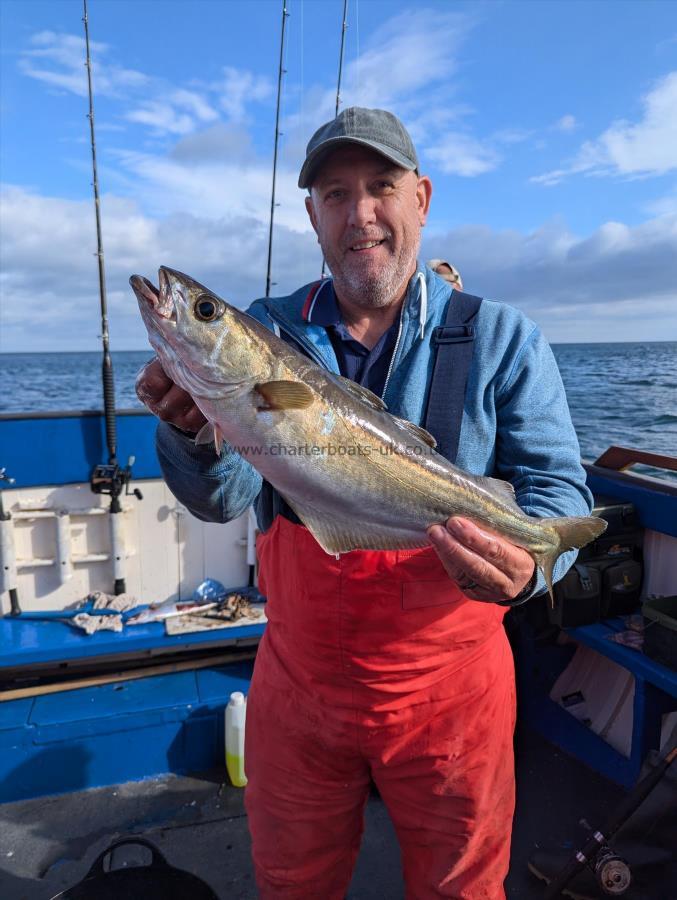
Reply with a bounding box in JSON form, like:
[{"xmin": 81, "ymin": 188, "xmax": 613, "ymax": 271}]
[{"xmin": 306, "ymin": 144, "xmax": 432, "ymax": 309}]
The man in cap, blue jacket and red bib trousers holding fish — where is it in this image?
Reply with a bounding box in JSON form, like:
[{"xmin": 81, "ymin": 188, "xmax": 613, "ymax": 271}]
[{"xmin": 138, "ymin": 108, "xmax": 590, "ymax": 900}]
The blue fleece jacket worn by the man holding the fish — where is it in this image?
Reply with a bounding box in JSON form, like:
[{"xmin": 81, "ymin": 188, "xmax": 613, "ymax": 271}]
[{"xmin": 157, "ymin": 267, "xmax": 592, "ymax": 593}]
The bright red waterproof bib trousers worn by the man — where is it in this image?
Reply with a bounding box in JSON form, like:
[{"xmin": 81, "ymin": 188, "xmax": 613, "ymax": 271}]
[{"xmin": 245, "ymin": 516, "xmax": 515, "ymax": 900}]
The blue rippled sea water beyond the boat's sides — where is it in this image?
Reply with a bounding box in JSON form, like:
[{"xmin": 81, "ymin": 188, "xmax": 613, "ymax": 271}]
[{"xmin": 0, "ymin": 341, "xmax": 677, "ymax": 478}]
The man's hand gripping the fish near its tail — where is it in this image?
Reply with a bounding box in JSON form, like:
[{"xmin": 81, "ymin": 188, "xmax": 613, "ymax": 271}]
[{"xmin": 428, "ymin": 517, "xmax": 535, "ymax": 601}]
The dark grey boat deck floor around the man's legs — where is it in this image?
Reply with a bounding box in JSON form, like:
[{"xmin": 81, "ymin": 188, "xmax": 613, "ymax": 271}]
[{"xmin": 0, "ymin": 729, "xmax": 624, "ymax": 900}]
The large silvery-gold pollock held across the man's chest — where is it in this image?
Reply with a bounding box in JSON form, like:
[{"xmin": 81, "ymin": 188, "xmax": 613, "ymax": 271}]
[{"xmin": 130, "ymin": 266, "xmax": 606, "ymax": 598}]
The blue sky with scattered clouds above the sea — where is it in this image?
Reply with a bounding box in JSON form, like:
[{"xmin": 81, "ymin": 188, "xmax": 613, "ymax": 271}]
[{"xmin": 0, "ymin": 0, "xmax": 677, "ymax": 352}]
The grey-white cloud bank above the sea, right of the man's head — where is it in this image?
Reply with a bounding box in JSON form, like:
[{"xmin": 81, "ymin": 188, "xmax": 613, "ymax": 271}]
[{"xmin": 423, "ymin": 214, "xmax": 677, "ymax": 341}]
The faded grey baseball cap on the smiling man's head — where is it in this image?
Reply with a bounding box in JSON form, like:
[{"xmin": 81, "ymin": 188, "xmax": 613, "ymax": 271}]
[{"xmin": 299, "ymin": 106, "xmax": 418, "ymax": 188}]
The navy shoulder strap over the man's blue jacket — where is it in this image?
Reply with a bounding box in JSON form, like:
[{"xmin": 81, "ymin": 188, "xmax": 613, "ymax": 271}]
[{"xmin": 424, "ymin": 290, "xmax": 482, "ymax": 463}]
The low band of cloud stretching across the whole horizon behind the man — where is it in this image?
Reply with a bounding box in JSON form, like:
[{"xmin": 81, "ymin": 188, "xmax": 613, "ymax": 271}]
[{"xmin": 0, "ymin": 179, "xmax": 677, "ymax": 351}]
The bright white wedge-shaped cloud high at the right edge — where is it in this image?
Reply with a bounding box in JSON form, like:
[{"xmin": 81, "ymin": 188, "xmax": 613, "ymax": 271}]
[{"xmin": 531, "ymin": 72, "xmax": 677, "ymax": 185}]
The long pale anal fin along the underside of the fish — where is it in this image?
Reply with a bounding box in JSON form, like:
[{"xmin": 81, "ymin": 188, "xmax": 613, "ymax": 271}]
[{"xmin": 285, "ymin": 497, "xmax": 429, "ymax": 555}]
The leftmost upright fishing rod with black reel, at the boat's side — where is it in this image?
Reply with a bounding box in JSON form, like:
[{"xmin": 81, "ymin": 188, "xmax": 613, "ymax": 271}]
[{"xmin": 82, "ymin": 0, "xmax": 143, "ymax": 594}]
